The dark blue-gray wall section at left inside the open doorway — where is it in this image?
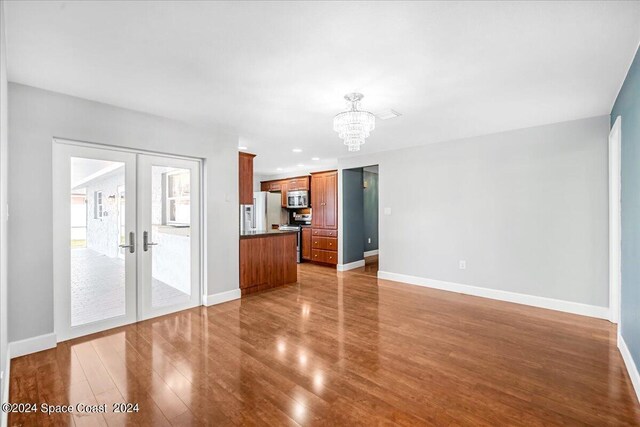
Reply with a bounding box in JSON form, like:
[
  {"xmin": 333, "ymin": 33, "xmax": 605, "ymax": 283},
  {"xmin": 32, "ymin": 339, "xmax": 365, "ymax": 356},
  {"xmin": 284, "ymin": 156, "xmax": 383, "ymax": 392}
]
[{"xmin": 342, "ymin": 168, "xmax": 364, "ymax": 264}]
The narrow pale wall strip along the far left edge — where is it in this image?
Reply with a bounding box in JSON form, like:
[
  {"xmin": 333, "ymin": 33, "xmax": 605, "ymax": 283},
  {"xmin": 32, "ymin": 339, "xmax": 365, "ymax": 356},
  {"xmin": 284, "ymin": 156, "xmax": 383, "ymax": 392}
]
[{"xmin": 0, "ymin": 1, "xmax": 9, "ymax": 408}]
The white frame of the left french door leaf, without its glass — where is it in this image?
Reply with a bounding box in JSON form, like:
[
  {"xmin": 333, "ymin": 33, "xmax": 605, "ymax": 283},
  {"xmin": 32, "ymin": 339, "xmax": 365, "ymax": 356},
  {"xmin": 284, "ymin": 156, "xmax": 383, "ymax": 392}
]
[{"xmin": 52, "ymin": 143, "xmax": 137, "ymax": 342}]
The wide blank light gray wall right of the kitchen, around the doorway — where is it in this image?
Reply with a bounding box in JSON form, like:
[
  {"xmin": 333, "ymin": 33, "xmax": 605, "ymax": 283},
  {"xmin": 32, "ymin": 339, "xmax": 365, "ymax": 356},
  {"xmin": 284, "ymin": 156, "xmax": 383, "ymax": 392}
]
[{"xmin": 339, "ymin": 116, "xmax": 609, "ymax": 307}]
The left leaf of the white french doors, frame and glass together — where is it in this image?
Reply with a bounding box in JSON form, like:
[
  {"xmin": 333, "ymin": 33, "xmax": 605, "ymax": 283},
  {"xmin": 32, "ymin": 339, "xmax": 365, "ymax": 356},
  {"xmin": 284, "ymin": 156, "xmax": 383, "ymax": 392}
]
[{"xmin": 53, "ymin": 143, "xmax": 136, "ymax": 339}]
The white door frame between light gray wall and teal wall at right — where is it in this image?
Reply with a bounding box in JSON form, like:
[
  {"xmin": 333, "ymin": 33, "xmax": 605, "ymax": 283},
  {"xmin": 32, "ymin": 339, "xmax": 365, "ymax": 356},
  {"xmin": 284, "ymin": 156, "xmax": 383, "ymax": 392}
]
[{"xmin": 609, "ymin": 116, "xmax": 622, "ymax": 323}]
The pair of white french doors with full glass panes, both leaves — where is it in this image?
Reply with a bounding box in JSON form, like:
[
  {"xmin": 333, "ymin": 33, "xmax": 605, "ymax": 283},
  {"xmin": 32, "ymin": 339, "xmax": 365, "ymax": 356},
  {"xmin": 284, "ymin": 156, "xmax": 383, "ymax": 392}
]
[{"xmin": 53, "ymin": 142, "xmax": 201, "ymax": 341}]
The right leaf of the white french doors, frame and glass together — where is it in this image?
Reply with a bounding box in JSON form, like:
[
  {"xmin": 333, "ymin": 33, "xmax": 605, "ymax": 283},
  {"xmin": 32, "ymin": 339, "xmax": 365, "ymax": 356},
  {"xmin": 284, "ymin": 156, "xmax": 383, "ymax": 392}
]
[{"xmin": 138, "ymin": 155, "xmax": 200, "ymax": 319}]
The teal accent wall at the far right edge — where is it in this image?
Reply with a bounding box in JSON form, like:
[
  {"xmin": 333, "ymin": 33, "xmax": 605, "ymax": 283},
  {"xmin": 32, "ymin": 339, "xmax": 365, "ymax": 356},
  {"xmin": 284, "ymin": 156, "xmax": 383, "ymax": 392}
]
[{"xmin": 611, "ymin": 45, "xmax": 640, "ymax": 369}]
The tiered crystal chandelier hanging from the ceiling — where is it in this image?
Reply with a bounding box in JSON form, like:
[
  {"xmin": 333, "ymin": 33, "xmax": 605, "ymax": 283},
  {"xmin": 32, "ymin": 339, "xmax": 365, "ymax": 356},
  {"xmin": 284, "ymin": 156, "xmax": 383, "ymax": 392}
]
[{"xmin": 333, "ymin": 93, "xmax": 376, "ymax": 151}]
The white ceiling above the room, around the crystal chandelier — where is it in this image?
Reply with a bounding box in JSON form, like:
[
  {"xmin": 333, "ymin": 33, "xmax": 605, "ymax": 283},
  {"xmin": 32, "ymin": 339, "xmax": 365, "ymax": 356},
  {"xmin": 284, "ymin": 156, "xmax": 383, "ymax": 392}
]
[{"xmin": 6, "ymin": 1, "xmax": 640, "ymax": 174}]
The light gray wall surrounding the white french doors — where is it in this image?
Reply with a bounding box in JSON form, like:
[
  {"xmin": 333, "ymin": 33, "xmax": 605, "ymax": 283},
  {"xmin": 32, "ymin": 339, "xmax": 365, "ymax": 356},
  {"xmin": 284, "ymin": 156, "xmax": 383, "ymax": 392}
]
[{"xmin": 9, "ymin": 83, "xmax": 238, "ymax": 341}]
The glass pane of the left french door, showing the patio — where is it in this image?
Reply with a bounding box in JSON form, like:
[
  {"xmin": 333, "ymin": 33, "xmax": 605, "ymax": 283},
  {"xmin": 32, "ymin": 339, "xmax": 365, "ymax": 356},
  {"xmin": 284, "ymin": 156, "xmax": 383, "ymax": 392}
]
[{"xmin": 70, "ymin": 157, "xmax": 125, "ymax": 327}]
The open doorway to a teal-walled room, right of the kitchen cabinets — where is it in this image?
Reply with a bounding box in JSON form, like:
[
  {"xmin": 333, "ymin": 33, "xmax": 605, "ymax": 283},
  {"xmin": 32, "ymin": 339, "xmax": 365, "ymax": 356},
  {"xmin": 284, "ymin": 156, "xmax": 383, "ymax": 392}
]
[{"xmin": 339, "ymin": 165, "xmax": 380, "ymax": 276}]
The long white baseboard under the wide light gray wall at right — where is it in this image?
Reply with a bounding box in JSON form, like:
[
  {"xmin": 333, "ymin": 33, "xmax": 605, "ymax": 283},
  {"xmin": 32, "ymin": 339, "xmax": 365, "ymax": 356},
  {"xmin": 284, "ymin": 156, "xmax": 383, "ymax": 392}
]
[{"xmin": 378, "ymin": 271, "xmax": 609, "ymax": 319}]
